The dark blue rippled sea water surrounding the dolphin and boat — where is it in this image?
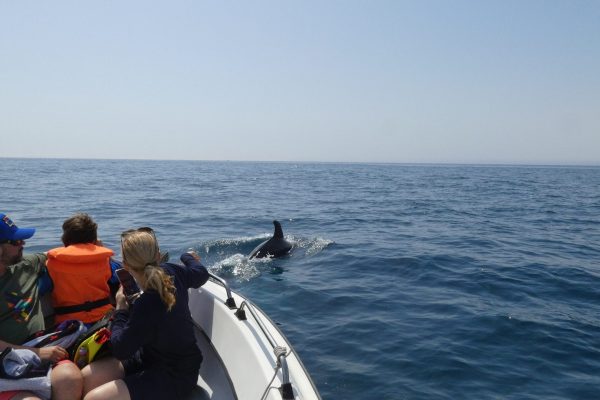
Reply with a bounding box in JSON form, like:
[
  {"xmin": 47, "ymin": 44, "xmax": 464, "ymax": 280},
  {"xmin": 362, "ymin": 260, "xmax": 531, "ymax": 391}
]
[{"xmin": 0, "ymin": 159, "xmax": 600, "ymax": 399}]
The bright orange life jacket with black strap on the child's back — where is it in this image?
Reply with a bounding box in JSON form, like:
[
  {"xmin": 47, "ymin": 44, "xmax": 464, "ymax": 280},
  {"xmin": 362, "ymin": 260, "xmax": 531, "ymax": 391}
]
[{"xmin": 46, "ymin": 243, "xmax": 114, "ymax": 324}]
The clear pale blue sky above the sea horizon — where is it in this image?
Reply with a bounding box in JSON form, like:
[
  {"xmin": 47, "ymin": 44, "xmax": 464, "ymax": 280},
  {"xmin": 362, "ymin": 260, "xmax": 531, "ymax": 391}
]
[{"xmin": 0, "ymin": 0, "xmax": 600, "ymax": 164}]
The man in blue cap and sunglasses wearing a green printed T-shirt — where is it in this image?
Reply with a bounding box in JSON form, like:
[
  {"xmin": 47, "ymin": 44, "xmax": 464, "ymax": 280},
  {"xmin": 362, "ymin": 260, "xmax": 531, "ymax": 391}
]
[{"xmin": 0, "ymin": 214, "xmax": 83, "ymax": 400}]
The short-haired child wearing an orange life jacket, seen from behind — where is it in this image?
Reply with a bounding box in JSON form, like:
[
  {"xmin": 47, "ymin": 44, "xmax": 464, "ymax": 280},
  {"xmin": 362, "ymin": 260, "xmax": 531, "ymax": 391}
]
[{"xmin": 46, "ymin": 213, "xmax": 114, "ymax": 324}]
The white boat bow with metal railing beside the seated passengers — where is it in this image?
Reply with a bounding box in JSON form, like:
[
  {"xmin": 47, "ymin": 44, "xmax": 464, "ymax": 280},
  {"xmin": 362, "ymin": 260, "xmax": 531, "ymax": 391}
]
[{"xmin": 189, "ymin": 274, "xmax": 321, "ymax": 400}]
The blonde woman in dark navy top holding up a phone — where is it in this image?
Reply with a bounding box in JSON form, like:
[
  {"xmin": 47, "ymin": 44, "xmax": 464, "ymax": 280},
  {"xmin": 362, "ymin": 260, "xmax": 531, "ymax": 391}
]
[{"xmin": 82, "ymin": 228, "xmax": 208, "ymax": 400}]
